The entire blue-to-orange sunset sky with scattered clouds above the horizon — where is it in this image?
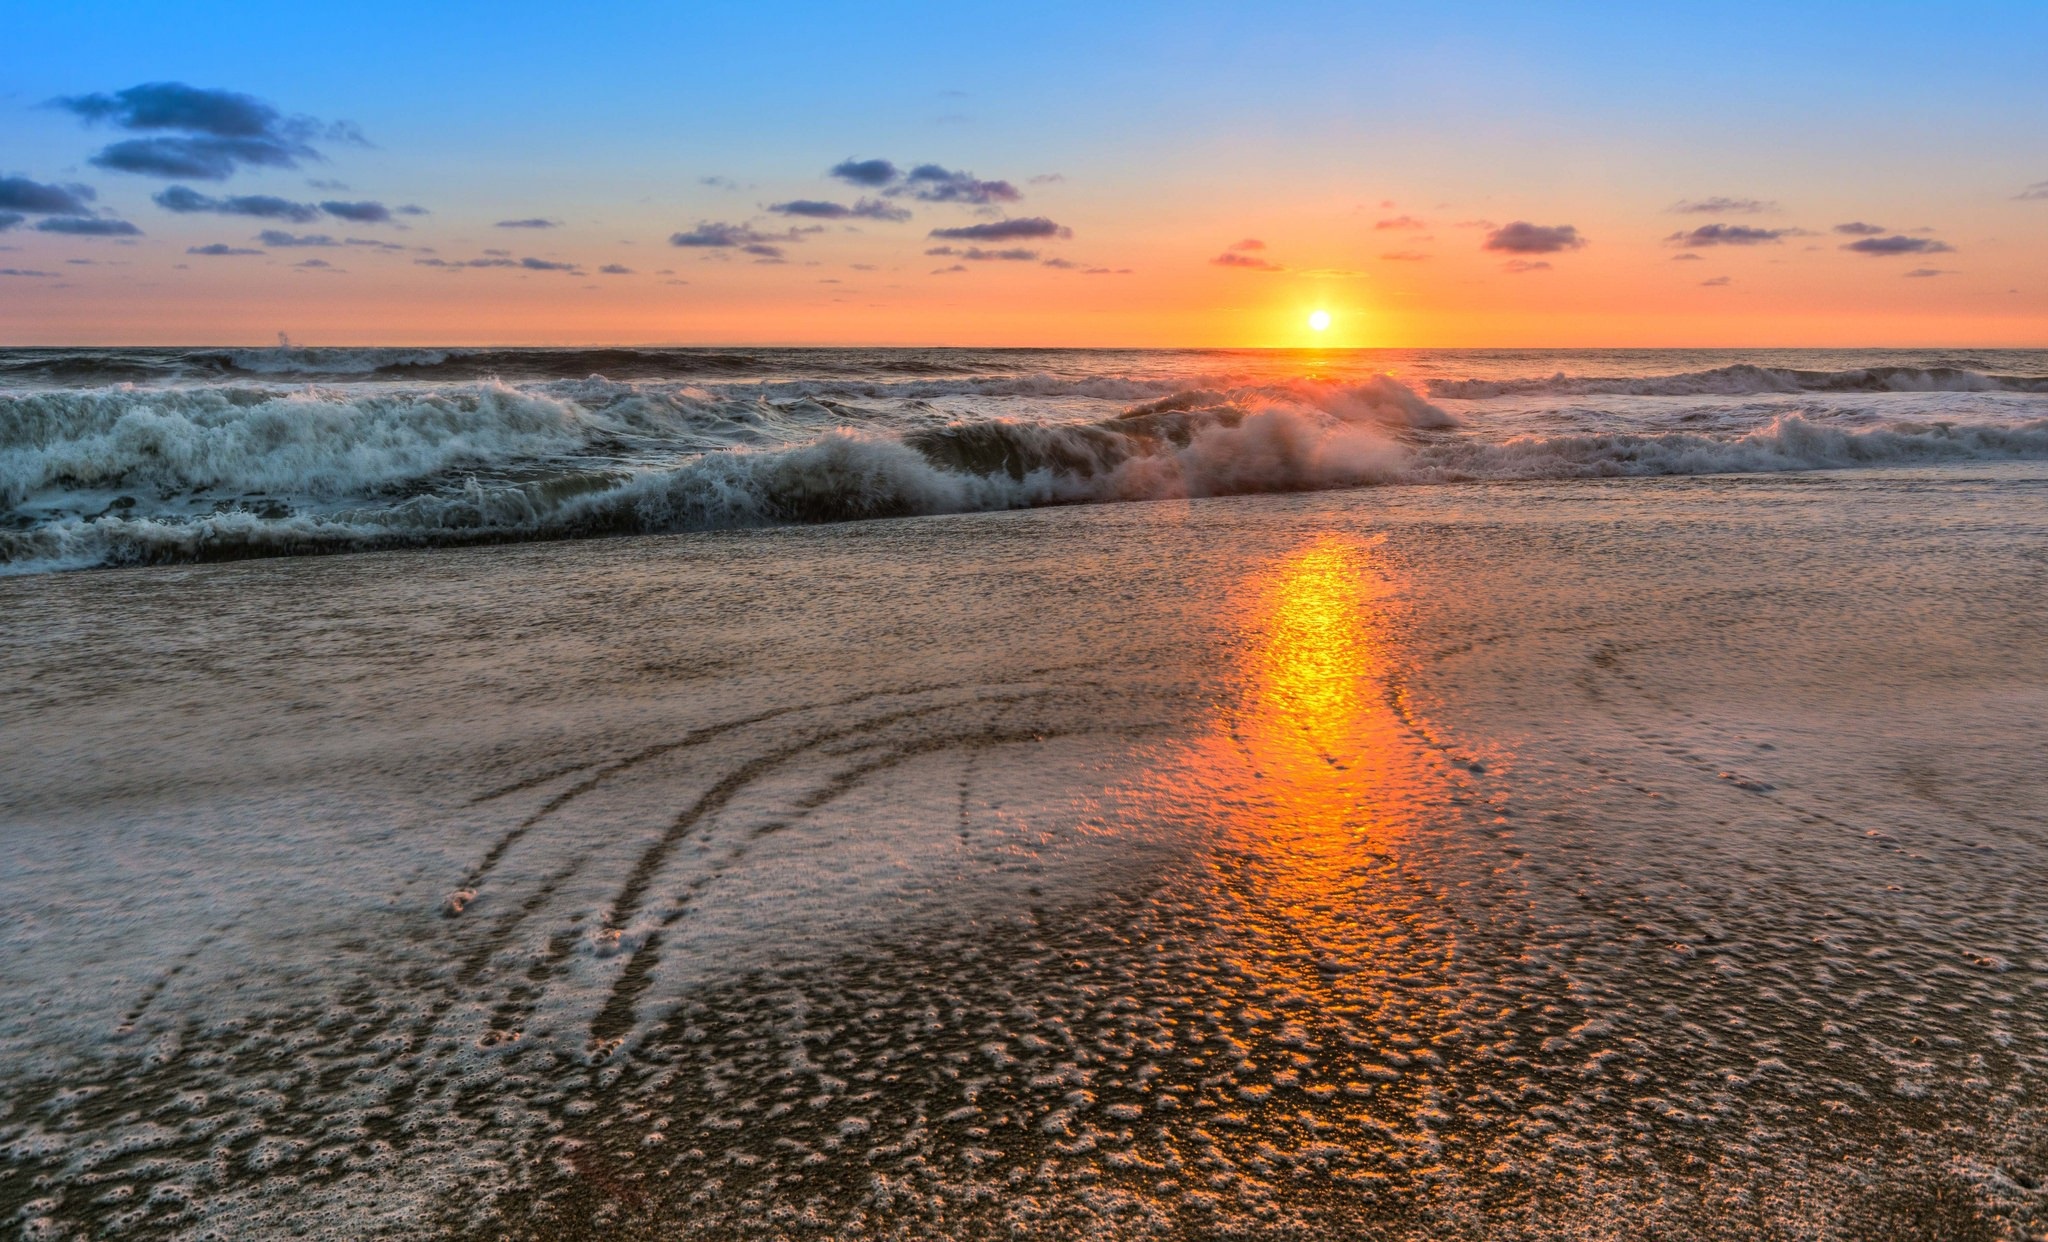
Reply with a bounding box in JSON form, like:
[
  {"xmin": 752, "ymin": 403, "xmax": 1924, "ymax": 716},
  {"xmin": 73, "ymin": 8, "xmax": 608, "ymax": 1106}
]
[{"xmin": 0, "ymin": 0, "xmax": 2048, "ymax": 346}]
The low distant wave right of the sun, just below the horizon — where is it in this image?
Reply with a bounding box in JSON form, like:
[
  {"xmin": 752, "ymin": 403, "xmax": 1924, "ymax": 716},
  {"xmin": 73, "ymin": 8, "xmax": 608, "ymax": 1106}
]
[{"xmin": 1430, "ymin": 363, "xmax": 2048, "ymax": 400}]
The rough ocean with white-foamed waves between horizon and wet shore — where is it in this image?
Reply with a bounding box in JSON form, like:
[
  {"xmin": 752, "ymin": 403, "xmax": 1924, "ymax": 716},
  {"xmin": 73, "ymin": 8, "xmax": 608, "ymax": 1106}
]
[{"xmin": 0, "ymin": 344, "xmax": 2048, "ymax": 572}]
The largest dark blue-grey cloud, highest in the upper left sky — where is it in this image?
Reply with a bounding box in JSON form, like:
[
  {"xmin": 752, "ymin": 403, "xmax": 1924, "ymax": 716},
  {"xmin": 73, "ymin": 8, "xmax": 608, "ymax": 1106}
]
[{"xmin": 51, "ymin": 82, "xmax": 362, "ymax": 180}]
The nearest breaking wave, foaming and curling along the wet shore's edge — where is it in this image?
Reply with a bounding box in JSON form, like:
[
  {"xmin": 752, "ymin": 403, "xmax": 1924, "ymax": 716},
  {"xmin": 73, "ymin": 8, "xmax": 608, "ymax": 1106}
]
[{"xmin": 0, "ymin": 394, "xmax": 2048, "ymax": 572}]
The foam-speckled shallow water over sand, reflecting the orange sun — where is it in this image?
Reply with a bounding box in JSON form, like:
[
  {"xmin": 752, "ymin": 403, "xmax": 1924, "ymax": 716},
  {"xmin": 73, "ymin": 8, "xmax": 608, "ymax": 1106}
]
[{"xmin": 0, "ymin": 463, "xmax": 2048, "ymax": 1240}]
